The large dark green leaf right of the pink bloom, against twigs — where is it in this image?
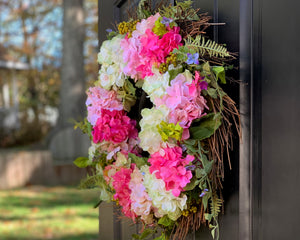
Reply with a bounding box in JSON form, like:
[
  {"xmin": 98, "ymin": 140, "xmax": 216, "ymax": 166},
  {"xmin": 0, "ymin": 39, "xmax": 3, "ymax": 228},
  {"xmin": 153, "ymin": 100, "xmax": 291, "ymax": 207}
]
[{"xmin": 190, "ymin": 113, "xmax": 222, "ymax": 140}]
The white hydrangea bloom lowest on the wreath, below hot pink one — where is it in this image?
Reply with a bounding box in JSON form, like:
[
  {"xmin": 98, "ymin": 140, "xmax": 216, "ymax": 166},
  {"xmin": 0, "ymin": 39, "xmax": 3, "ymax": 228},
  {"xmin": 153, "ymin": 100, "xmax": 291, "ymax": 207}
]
[{"xmin": 141, "ymin": 166, "xmax": 187, "ymax": 221}]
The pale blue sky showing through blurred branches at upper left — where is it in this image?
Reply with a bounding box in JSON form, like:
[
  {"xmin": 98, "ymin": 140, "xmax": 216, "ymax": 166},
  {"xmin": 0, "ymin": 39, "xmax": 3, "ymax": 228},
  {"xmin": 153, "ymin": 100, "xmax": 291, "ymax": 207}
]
[{"xmin": 0, "ymin": 0, "xmax": 63, "ymax": 69}]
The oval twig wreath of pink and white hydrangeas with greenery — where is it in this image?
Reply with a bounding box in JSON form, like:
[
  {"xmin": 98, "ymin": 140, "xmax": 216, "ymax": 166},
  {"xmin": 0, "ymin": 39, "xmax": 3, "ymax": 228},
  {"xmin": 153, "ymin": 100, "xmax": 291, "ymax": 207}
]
[{"xmin": 74, "ymin": 0, "xmax": 240, "ymax": 239}]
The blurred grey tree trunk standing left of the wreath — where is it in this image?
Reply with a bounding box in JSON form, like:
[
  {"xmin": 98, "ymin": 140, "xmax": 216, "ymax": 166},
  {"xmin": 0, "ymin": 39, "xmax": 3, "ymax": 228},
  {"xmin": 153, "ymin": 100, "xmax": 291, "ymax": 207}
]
[{"xmin": 58, "ymin": 0, "xmax": 85, "ymax": 127}]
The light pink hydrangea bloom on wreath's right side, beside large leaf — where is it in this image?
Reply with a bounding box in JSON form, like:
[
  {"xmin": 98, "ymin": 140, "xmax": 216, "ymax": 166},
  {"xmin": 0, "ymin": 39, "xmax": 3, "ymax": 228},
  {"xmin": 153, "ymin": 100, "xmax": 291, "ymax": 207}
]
[{"xmin": 156, "ymin": 74, "xmax": 208, "ymax": 139}]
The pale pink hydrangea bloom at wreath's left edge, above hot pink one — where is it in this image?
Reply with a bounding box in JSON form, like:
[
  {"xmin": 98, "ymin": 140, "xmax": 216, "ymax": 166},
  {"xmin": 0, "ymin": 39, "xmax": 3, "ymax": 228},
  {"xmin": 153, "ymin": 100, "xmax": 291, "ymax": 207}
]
[{"xmin": 85, "ymin": 87, "xmax": 123, "ymax": 126}]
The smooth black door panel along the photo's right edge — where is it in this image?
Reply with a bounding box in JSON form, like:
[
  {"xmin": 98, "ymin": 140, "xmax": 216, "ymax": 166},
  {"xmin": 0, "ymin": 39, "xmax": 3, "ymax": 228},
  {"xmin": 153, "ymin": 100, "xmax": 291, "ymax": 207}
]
[{"xmin": 261, "ymin": 0, "xmax": 300, "ymax": 240}]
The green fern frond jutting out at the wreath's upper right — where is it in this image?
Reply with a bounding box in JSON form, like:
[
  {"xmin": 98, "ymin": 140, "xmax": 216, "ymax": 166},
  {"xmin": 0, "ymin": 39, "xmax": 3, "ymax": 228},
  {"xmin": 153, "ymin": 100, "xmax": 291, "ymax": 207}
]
[{"xmin": 185, "ymin": 35, "xmax": 231, "ymax": 58}]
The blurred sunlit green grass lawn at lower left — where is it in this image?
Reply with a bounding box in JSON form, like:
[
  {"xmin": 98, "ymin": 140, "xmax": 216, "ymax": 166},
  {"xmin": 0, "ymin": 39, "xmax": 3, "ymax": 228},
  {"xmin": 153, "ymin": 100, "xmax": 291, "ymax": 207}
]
[{"xmin": 0, "ymin": 186, "xmax": 98, "ymax": 240}]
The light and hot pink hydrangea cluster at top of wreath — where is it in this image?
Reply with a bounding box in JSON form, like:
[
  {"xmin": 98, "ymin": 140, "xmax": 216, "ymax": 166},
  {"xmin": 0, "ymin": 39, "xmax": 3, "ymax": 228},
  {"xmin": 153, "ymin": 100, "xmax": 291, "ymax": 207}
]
[{"xmin": 121, "ymin": 14, "xmax": 182, "ymax": 80}]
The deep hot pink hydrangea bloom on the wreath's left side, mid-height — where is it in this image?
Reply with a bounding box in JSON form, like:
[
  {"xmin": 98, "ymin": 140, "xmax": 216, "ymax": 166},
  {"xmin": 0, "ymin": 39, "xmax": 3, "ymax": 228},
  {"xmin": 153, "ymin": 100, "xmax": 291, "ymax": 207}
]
[{"xmin": 92, "ymin": 109, "xmax": 138, "ymax": 143}]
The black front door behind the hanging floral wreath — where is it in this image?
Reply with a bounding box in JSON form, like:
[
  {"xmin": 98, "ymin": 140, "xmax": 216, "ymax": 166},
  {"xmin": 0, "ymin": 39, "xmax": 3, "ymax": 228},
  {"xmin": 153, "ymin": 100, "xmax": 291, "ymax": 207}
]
[{"xmin": 99, "ymin": 0, "xmax": 300, "ymax": 240}]
